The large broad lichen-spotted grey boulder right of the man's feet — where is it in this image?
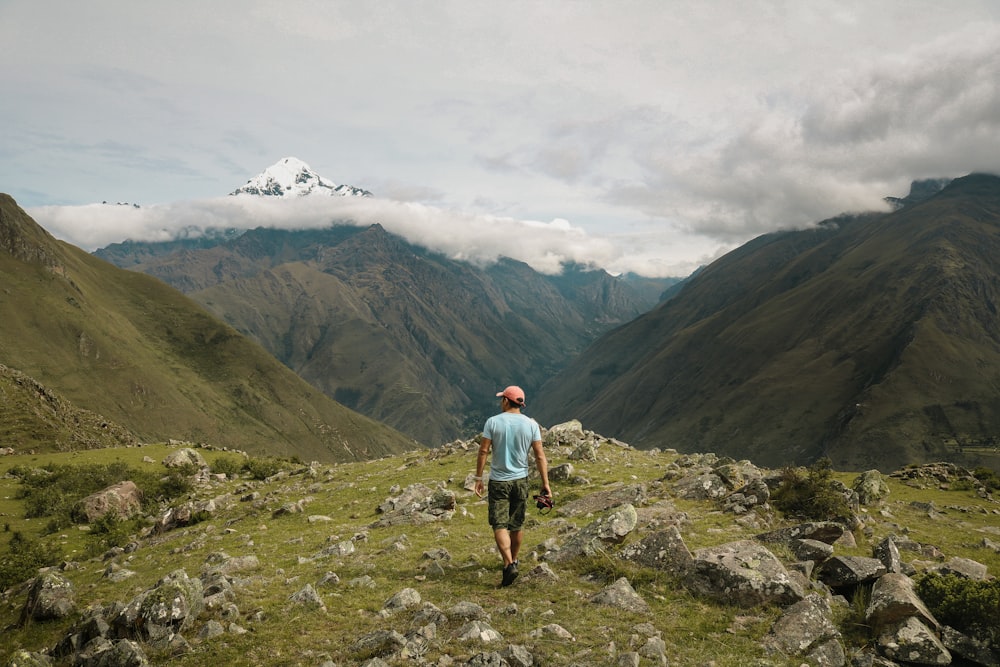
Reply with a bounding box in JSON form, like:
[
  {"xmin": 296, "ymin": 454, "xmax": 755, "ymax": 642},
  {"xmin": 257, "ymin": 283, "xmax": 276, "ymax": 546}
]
[{"xmin": 684, "ymin": 540, "xmax": 803, "ymax": 607}]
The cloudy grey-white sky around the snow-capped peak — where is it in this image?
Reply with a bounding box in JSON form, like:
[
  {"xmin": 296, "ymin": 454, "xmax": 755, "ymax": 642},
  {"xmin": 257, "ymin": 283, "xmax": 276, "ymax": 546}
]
[{"xmin": 0, "ymin": 0, "xmax": 1000, "ymax": 275}]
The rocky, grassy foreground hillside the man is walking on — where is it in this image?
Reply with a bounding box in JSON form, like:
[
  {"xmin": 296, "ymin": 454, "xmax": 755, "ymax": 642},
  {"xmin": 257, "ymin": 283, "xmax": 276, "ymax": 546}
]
[{"xmin": 0, "ymin": 430, "xmax": 1000, "ymax": 667}]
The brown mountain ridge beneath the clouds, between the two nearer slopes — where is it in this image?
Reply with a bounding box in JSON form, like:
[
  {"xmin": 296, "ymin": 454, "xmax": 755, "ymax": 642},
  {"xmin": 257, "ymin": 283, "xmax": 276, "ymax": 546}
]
[{"xmin": 95, "ymin": 225, "xmax": 672, "ymax": 446}]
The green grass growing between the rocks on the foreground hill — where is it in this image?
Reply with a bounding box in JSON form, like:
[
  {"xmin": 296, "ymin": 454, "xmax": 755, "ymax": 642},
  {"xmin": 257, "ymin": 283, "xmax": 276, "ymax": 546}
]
[{"xmin": 0, "ymin": 445, "xmax": 1000, "ymax": 667}]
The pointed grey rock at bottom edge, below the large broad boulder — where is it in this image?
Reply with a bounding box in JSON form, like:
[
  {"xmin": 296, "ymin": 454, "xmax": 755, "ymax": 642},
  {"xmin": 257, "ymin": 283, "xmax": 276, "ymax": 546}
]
[{"xmin": 764, "ymin": 593, "xmax": 846, "ymax": 665}]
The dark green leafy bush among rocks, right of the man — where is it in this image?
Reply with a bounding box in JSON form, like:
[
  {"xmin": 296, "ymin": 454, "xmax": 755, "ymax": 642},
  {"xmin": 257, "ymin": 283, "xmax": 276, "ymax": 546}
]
[{"xmin": 771, "ymin": 458, "xmax": 854, "ymax": 522}]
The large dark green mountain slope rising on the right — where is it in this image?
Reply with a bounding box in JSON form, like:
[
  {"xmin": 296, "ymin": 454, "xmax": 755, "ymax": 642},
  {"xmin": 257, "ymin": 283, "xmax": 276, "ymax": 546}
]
[{"xmin": 536, "ymin": 175, "xmax": 1000, "ymax": 470}]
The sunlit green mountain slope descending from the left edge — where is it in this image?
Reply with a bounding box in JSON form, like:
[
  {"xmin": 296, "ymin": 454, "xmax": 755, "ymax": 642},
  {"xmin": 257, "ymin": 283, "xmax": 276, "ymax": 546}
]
[{"xmin": 0, "ymin": 195, "xmax": 413, "ymax": 461}]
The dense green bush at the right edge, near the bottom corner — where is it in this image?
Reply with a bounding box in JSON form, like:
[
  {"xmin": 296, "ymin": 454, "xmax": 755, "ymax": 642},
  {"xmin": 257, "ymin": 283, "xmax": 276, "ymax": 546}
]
[{"xmin": 915, "ymin": 572, "xmax": 1000, "ymax": 641}]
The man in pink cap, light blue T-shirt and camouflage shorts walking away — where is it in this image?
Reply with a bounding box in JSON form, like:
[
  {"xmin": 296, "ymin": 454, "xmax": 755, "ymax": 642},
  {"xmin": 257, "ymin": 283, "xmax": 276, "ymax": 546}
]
[{"xmin": 475, "ymin": 386, "xmax": 551, "ymax": 586}]
